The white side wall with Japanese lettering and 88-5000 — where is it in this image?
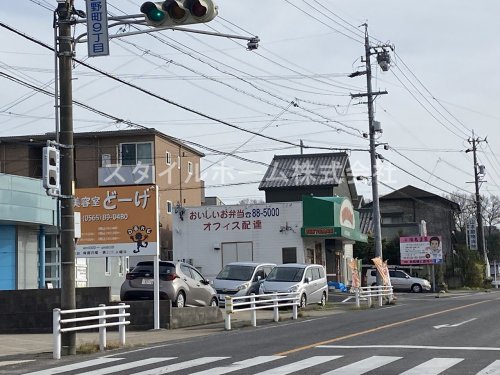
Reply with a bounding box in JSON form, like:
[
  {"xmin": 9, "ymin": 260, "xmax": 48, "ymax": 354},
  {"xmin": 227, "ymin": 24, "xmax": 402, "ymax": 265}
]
[{"xmin": 173, "ymin": 202, "xmax": 304, "ymax": 278}]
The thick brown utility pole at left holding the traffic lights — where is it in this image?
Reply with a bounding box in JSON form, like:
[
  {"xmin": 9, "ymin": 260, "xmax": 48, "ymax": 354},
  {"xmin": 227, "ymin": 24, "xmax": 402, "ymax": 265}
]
[{"xmin": 56, "ymin": 0, "xmax": 76, "ymax": 355}]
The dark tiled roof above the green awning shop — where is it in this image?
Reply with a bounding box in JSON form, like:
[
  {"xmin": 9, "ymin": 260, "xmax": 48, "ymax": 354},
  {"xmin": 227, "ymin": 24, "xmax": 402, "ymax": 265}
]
[{"xmin": 259, "ymin": 152, "xmax": 348, "ymax": 190}]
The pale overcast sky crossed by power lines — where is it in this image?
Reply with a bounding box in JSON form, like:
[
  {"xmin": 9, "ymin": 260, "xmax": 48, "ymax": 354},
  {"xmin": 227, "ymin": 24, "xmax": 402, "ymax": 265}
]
[{"xmin": 0, "ymin": 0, "xmax": 500, "ymax": 204}]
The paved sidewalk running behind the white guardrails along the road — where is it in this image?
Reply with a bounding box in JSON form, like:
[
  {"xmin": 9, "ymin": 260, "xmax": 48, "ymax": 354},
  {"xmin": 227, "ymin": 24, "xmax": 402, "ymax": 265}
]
[{"xmin": 0, "ymin": 303, "xmax": 346, "ymax": 360}]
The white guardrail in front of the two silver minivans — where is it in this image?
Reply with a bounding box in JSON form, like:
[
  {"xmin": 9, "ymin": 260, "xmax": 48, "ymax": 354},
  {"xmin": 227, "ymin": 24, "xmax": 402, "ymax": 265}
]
[{"xmin": 224, "ymin": 293, "xmax": 299, "ymax": 331}]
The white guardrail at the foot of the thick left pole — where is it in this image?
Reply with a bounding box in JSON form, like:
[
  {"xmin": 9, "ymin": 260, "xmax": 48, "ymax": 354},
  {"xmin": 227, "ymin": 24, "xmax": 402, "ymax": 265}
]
[{"xmin": 52, "ymin": 303, "xmax": 130, "ymax": 359}]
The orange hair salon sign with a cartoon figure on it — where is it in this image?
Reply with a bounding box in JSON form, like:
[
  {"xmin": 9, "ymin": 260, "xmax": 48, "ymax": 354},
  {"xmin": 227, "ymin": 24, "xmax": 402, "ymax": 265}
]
[{"xmin": 74, "ymin": 186, "xmax": 158, "ymax": 258}]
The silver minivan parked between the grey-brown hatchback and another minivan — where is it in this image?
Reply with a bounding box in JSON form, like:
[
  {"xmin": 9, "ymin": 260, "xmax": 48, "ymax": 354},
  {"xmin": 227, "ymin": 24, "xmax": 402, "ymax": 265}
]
[{"xmin": 213, "ymin": 262, "xmax": 276, "ymax": 306}]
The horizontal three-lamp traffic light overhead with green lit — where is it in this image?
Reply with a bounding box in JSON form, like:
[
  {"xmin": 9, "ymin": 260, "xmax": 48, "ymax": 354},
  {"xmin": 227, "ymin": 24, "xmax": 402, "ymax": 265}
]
[{"xmin": 141, "ymin": 0, "xmax": 217, "ymax": 27}]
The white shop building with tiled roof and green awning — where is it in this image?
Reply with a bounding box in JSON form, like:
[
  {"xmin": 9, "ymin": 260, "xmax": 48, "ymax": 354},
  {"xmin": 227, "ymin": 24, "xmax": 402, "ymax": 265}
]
[{"xmin": 174, "ymin": 153, "xmax": 367, "ymax": 284}]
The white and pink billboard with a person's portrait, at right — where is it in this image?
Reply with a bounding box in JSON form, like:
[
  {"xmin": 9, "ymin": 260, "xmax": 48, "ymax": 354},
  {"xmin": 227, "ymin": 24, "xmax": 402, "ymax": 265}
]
[{"xmin": 399, "ymin": 236, "xmax": 443, "ymax": 265}]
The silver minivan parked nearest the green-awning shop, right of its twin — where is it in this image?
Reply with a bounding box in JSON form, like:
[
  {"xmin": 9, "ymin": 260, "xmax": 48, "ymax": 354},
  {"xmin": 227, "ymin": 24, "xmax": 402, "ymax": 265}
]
[{"xmin": 259, "ymin": 263, "xmax": 328, "ymax": 308}]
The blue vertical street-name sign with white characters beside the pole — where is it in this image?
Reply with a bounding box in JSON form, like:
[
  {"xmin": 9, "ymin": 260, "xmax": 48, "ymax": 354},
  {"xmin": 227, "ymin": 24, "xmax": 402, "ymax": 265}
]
[{"xmin": 87, "ymin": 0, "xmax": 109, "ymax": 57}]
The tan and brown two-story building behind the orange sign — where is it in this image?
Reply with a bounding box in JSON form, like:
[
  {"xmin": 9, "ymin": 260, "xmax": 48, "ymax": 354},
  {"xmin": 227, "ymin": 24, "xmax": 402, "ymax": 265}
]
[{"xmin": 0, "ymin": 129, "xmax": 204, "ymax": 293}]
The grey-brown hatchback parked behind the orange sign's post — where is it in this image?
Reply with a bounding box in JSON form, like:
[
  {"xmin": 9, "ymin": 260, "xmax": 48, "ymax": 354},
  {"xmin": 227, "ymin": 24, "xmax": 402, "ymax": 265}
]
[{"xmin": 120, "ymin": 261, "xmax": 217, "ymax": 307}]
